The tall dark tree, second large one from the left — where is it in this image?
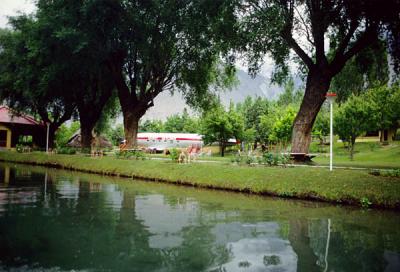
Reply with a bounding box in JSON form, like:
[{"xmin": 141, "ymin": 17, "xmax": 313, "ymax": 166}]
[{"xmin": 37, "ymin": 0, "xmax": 118, "ymax": 148}]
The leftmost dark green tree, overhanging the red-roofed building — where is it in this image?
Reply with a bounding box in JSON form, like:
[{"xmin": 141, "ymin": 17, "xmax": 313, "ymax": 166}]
[{"xmin": 0, "ymin": 16, "xmax": 76, "ymax": 147}]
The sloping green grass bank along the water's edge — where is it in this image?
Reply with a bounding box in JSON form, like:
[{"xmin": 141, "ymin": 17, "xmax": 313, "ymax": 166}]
[{"xmin": 0, "ymin": 152, "xmax": 400, "ymax": 209}]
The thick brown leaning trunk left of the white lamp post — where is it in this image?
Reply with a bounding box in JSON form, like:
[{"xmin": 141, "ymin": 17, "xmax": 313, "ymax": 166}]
[{"xmin": 292, "ymin": 72, "xmax": 331, "ymax": 153}]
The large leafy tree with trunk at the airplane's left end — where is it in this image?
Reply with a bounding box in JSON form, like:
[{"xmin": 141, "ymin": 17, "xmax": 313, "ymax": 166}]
[{"xmin": 108, "ymin": 0, "xmax": 234, "ymax": 146}]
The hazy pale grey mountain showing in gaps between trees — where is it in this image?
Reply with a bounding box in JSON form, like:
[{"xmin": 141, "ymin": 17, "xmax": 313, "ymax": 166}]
[{"xmin": 143, "ymin": 69, "xmax": 283, "ymax": 120}]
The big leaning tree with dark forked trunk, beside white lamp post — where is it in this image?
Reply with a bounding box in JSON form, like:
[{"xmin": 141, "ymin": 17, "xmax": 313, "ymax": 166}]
[{"xmin": 236, "ymin": 0, "xmax": 400, "ymax": 153}]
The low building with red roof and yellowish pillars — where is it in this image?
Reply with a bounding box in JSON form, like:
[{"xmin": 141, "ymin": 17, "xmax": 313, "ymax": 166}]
[{"xmin": 0, "ymin": 106, "xmax": 46, "ymax": 149}]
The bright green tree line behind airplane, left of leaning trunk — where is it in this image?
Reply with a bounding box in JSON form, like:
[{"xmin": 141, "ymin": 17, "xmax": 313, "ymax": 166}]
[{"xmin": 134, "ymin": 81, "xmax": 302, "ymax": 156}]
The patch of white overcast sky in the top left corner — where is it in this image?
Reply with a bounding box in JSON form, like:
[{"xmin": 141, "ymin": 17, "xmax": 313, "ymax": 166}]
[{"xmin": 0, "ymin": 0, "xmax": 35, "ymax": 28}]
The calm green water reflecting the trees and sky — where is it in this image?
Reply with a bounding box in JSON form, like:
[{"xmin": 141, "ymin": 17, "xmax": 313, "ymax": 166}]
[{"xmin": 0, "ymin": 164, "xmax": 400, "ymax": 272}]
